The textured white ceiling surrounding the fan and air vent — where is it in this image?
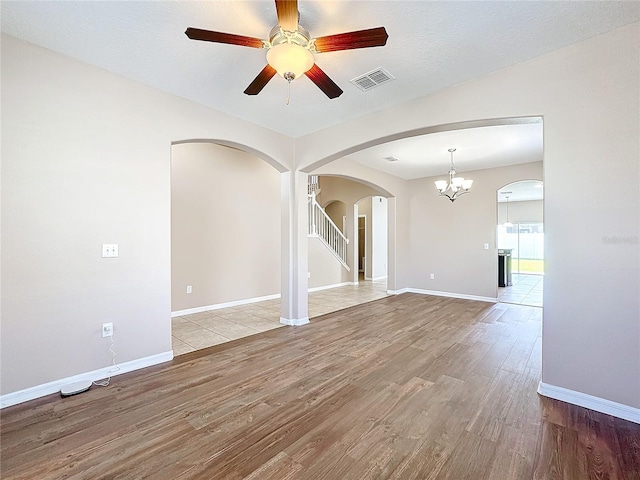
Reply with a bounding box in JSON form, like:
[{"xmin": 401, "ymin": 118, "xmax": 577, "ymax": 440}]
[{"xmin": 0, "ymin": 0, "xmax": 640, "ymax": 141}]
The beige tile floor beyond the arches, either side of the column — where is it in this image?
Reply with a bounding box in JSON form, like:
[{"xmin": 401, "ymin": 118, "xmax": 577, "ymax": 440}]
[{"xmin": 171, "ymin": 280, "xmax": 387, "ymax": 355}]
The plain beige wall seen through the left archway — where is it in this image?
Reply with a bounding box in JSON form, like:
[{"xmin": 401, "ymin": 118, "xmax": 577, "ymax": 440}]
[{"xmin": 171, "ymin": 143, "xmax": 280, "ymax": 311}]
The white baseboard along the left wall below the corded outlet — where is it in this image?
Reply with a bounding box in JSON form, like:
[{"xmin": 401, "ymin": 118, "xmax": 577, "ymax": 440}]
[{"xmin": 0, "ymin": 350, "xmax": 173, "ymax": 408}]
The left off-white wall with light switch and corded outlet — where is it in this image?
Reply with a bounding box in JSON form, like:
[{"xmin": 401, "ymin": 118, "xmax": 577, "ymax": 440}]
[{"xmin": 0, "ymin": 35, "xmax": 293, "ymax": 395}]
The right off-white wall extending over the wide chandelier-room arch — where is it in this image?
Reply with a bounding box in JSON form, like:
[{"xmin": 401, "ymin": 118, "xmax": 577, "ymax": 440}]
[{"xmin": 296, "ymin": 23, "xmax": 640, "ymax": 408}]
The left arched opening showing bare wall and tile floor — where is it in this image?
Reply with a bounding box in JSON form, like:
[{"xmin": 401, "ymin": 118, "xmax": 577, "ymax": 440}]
[{"xmin": 171, "ymin": 141, "xmax": 281, "ymax": 355}]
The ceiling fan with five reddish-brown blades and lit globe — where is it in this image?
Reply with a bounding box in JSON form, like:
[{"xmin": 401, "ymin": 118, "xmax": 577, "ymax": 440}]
[{"xmin": 184, "ymin": 0, "xmax": 389, "ymax": 98}]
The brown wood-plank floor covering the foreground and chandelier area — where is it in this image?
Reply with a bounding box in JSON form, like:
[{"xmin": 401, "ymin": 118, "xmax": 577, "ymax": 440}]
[{"xmin": 0, "ymin": 294, "xmax": 640, "ymax": 480}]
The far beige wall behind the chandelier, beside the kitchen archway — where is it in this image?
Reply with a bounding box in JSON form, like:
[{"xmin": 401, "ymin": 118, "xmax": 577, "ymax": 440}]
[{"xmin": 408, "ymin": 162, "xmax": 542, "ymax": 299}]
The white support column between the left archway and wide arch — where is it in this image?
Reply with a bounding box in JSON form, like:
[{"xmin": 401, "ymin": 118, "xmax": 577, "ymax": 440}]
[{"xmin": 280, "ymin": 172, "xmax": 309, "ymax": 325}]
